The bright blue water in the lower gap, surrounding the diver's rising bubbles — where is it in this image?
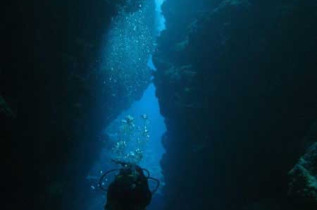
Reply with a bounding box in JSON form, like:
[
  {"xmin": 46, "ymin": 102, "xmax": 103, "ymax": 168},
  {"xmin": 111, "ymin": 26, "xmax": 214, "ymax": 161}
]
[{"xmin": 87, "ymin": 84, "xmax": 166, "ymax": 210}]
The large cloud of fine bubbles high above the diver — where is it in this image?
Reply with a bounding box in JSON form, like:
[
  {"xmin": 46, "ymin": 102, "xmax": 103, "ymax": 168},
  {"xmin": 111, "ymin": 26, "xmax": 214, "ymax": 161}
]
[{"xmin": 102, "ymin": 1, "xmax": 155, "ymax": 104}]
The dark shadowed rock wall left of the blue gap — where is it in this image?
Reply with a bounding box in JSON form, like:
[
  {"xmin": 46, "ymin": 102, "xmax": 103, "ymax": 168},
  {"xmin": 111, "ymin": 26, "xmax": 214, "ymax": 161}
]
[{"xmin": 0, "ymin": 0, "xmax": 149, "ymax": 210}]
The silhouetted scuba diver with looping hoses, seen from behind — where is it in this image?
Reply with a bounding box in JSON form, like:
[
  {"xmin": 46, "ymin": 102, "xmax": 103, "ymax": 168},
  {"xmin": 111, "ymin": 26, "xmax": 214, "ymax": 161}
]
[{"xmin": 99, "ymin": 160, "xmax": 160, "ymax": 210}]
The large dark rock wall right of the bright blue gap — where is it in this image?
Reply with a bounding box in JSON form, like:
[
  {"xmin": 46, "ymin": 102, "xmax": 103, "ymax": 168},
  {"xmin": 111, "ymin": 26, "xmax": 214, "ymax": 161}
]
[{"xmin": 153, "ymin": 0, "xmax": 317, "ymax": 210}]
